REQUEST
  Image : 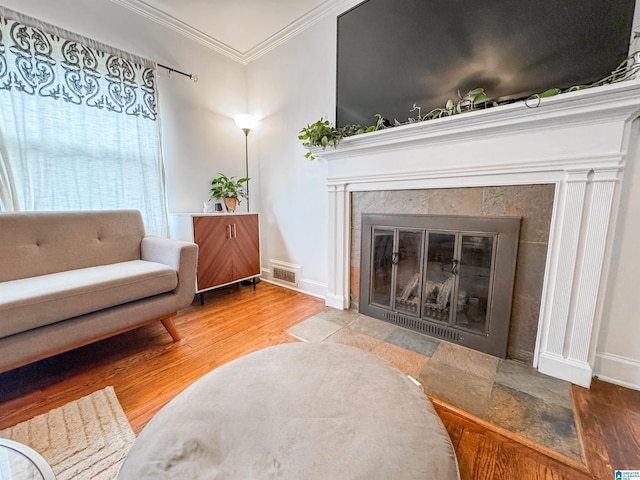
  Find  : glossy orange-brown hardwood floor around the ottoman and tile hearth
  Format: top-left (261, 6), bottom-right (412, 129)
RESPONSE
top-left (0, 282), bottom-right (640, 480)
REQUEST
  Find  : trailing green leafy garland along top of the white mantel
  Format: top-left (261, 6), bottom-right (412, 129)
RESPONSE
top-left (298, 32), bottom-right (640, 160)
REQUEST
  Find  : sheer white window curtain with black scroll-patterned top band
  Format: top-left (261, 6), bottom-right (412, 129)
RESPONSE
top-left (0, 7), bottom-right (167, 236)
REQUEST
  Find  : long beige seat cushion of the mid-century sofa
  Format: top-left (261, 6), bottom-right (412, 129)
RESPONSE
top-left (0, 260), bottom-right (178, 337)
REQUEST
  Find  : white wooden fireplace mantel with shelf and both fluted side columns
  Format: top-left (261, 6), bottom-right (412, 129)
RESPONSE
top-left (314, 80), bottom-right (640, 387)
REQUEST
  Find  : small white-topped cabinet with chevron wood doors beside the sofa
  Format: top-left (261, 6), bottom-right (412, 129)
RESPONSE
top-left (170, 213), bottom-right (260, 293)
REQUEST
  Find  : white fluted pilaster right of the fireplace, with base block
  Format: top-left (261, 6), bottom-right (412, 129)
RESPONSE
top-left (537, 168), bottom-right (619, 386)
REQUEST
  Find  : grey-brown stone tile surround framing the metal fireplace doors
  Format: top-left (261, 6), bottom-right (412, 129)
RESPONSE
top-left (349, 184), bottom-right (555, 365)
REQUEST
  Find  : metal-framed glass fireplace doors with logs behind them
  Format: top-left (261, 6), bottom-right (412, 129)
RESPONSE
top-left (359, 214), bottom-right (520, 358)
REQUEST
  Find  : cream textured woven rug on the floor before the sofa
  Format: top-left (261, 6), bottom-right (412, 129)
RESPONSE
top-left (0, 387), bottom-right (135, 480)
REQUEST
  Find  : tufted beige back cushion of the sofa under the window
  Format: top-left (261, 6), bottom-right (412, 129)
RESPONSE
top-left (0, 210), bottom-right (144, 281)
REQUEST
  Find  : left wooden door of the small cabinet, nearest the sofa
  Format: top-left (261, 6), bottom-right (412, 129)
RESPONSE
top-left (193, 217), bottom-right (236, 290)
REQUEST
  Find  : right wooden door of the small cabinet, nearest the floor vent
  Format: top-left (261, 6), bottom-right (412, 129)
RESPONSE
top-left (232, 215), bottom-right (260, 280)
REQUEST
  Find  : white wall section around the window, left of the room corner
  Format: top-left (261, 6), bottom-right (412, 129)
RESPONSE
top-left (0, 0), bottom-right (246, 212)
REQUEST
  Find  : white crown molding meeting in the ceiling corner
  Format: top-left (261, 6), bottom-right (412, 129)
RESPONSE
top-left (111, 0), bottom-right (353, 65)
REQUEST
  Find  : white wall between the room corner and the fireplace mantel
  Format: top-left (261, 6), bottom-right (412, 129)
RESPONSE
top-left (247, 17), bottom-right (344, 295)
